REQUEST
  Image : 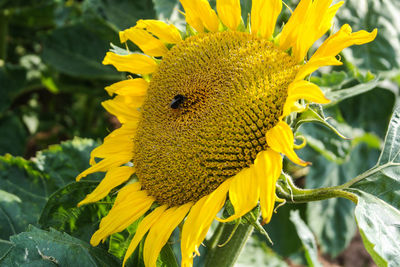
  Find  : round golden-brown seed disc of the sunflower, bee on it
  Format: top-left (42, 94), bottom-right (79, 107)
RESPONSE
top-left (132, 32), bottom-right (299, 207)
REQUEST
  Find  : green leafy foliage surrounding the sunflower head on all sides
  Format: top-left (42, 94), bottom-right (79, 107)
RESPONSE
top-left (0, 0), bottom-right (400, 266)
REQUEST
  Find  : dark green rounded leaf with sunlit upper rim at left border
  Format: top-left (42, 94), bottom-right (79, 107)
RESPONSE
top-left (0, 155), bottom-right (48, 244)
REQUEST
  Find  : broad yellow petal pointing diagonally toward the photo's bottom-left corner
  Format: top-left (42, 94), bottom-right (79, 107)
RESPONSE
top-left (90, 182), bottom-right (154, 246)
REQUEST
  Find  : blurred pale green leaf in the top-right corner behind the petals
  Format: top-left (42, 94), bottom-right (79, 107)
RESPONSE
top-left (337, 0), bottom-right (400, 72)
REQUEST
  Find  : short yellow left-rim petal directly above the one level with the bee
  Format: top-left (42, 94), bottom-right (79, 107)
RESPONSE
top-left (105, 78), bottom-right (149, 96)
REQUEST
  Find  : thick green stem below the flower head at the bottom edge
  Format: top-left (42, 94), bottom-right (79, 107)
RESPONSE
top-left (205, 223), bottom-right (253, 267)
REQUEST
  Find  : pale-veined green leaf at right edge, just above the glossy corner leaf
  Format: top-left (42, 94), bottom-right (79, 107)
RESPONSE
top-left (352, 103), bottom-right (400, 209)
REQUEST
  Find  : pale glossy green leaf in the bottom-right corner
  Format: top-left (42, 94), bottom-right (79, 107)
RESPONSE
top-left (354, 190), bottom-right (400, 266)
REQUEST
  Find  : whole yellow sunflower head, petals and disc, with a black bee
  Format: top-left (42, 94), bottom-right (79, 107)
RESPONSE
top-left (77, 0), bottom-right (377, 266)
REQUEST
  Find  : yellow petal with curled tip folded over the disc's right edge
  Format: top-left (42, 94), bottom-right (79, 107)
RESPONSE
top-left (266, 121), bottom-right (308, 166)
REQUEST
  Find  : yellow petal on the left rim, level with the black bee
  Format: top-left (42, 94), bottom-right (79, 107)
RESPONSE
top-left (101, 96), bottom-right (144, 123)
